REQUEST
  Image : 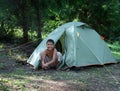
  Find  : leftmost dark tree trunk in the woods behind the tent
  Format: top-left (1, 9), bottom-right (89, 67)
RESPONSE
top-left (13, 0), bottom-right (29, 42)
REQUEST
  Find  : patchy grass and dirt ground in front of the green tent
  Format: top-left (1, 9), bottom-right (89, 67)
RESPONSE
top-left (0, 52), bottom-right (120, 91)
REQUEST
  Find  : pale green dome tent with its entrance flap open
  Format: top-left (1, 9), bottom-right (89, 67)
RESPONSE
top-left (27, 22), bottom-right (117, 69)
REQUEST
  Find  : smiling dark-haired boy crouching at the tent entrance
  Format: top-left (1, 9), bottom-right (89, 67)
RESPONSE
top-left (41, 39), bottom-right (62, 69)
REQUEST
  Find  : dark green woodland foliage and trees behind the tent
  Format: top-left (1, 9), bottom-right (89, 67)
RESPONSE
top-left (0, 0), bottom-right (120, 43)
